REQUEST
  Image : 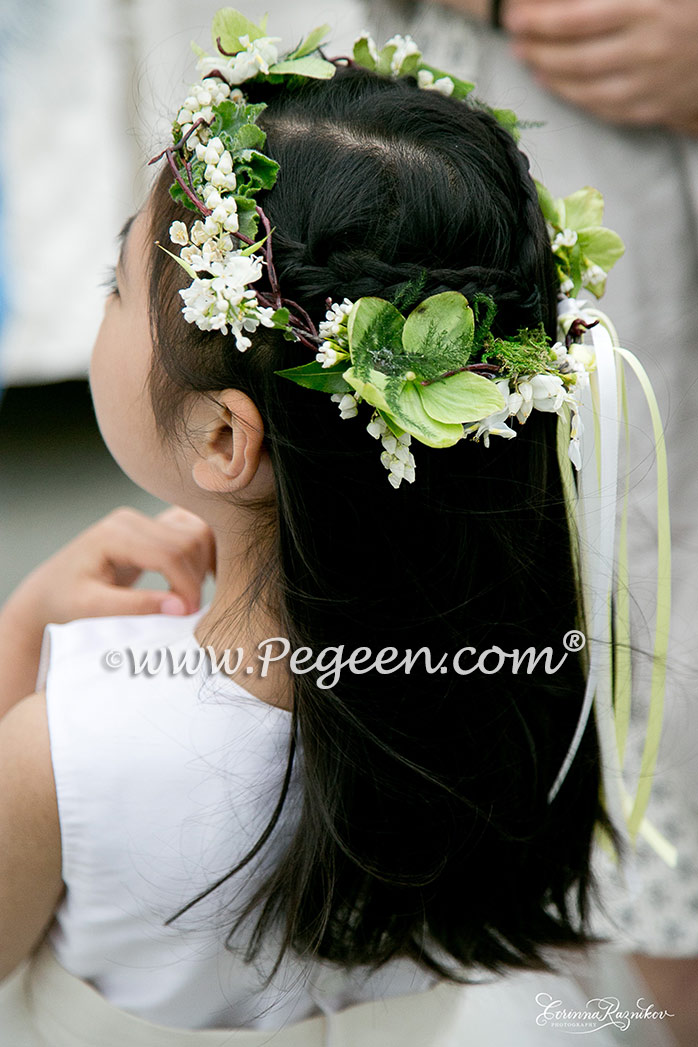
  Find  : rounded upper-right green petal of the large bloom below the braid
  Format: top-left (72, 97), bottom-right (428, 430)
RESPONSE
top-left (402, 291), bottom-right (475, 370)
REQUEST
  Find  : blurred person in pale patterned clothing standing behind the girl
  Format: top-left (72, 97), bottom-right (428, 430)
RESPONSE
top-left (371, 0), bottom-right (698, 1044)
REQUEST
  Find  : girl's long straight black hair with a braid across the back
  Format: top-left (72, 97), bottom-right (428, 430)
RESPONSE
top-left (146, 69), bottom-right (608, 980)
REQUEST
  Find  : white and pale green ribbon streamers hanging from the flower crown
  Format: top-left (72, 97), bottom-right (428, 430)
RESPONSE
top-left (548, 298), bottom-right (676, 865)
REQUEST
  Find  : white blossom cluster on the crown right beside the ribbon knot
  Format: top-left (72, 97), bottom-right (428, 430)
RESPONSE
top-left (465, 342), bottom-right (594, 469)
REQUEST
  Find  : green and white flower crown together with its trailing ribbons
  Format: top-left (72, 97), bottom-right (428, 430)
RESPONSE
top-left (151, 7), bottom-right (676, 864)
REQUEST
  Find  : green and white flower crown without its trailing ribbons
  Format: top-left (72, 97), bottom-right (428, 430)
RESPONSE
top-left (151, 7), bottom-right (624, 488)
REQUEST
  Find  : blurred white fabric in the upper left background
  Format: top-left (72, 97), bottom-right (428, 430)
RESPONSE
top-left (0, 0), bottom-right (364, 385)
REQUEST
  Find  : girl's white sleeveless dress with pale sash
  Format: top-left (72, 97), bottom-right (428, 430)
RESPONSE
top-left (0, 612), bottom-right (662, 1047)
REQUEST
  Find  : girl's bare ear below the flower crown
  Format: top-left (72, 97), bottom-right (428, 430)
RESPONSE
top-left (192, 389), bottom-right (264, 493)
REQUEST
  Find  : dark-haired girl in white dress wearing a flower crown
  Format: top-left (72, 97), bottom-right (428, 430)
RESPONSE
top-left (0, 10), bottom-right (644, 1047)
